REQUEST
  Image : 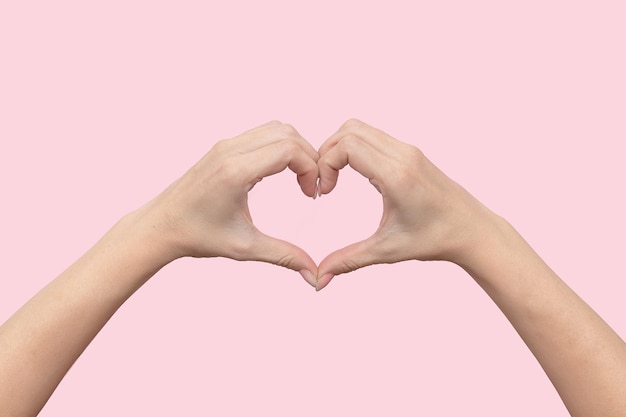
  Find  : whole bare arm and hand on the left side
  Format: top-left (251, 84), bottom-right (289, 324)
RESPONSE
top-left (0, 122), bottom-right (318, 417)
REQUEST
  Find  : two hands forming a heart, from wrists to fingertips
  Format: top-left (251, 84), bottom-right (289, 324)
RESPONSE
top-left (149, 120), bottom-right (492, 290)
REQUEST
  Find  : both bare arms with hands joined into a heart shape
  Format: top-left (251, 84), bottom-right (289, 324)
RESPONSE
top-left (0, 120), bottom-right (626, 417)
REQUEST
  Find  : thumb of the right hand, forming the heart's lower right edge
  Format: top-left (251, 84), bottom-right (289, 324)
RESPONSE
top-left (315, 235), bottom-right (385, 291)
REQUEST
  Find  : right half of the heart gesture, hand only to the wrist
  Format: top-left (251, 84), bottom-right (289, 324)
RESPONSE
top-left (317, 120), bottom-right (496, 290)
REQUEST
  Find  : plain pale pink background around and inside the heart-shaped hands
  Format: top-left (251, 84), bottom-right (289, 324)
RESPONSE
top-left (0, 0), bottom-right (626, 417)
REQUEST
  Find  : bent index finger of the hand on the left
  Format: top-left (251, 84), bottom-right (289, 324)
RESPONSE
top-left (241, 140), bottom-right (319, 197)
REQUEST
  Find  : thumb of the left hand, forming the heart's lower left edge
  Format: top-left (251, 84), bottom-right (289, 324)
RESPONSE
top-left (246, 231), bottom-right (317, 287)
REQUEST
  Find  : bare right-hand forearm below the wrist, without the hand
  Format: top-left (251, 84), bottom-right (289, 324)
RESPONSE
top-left (460, 219), bottom-right (626, 417)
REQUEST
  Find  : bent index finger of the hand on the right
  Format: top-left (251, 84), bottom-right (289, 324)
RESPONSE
top-left (317, 134), bottom-right (387, 194)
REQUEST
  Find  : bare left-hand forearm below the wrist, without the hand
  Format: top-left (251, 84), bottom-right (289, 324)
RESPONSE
top-left (0, 206), bottom-right (172, 417)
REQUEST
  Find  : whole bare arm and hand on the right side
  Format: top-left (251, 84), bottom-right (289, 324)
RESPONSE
top-left (317, 120), bottom-right (626, 417)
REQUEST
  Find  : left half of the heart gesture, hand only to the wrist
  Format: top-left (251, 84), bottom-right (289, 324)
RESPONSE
top-left (141, 118), bottom-right (318, 286)
